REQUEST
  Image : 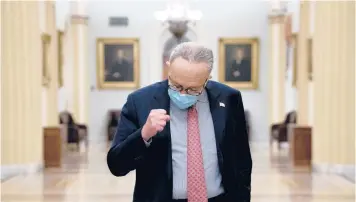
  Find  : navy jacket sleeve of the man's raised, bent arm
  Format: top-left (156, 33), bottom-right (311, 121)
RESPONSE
top-left (107, 95), bottom-right (147, 176)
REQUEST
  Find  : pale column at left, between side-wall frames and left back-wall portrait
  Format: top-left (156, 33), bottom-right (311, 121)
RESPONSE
top-left (66, 1), bottom-right (89, 124)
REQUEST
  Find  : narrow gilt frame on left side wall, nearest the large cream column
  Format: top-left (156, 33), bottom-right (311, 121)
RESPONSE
top-left (41, 34), bottom-right (51, 87)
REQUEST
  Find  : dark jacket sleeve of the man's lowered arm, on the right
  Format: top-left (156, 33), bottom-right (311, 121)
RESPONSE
top-left (234, 92), bottom-right (252, 202)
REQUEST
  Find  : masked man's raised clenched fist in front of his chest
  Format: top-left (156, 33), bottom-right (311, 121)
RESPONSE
top-left (142, 109), bottom-right (169, 141)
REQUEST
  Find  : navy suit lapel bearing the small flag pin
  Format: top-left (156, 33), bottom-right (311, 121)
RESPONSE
top-left (206, 81), bottom-right (226, 147)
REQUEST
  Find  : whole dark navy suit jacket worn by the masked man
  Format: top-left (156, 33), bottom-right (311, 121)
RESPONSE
top-left (107, 80), bottom-right (252, 202)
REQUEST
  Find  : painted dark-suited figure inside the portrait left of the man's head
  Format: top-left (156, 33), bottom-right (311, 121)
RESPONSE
top-left (105, 49), bottom-right (133, 81)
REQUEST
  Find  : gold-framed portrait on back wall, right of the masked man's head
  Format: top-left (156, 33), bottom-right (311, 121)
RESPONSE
top-left (219, 38), bottom-right (259, 89)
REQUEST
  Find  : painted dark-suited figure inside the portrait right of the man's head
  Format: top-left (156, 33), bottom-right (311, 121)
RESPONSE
top-left (225, 48), bottom-right (251, 82)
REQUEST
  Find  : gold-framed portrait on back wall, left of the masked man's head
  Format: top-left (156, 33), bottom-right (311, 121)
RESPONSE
top-left (96, 38), bottom-right (140, 89)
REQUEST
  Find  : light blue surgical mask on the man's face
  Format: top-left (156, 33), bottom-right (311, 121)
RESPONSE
top-left (168, 89), bottom-right (198, 109)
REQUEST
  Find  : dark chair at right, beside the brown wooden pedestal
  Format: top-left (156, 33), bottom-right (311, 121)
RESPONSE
top-left (270, 111), bottom-right (297, 149)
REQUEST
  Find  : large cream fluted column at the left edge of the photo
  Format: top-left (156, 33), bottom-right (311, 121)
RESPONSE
top-left (1, 1), bottom-right (43, 173)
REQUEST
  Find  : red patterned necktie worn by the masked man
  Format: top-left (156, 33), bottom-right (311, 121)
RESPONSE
top-left (187, 106), bottom-right (208, 202)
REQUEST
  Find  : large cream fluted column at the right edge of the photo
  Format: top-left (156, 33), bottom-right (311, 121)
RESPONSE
top-left (313, 1), bottom-right (355, 178)
